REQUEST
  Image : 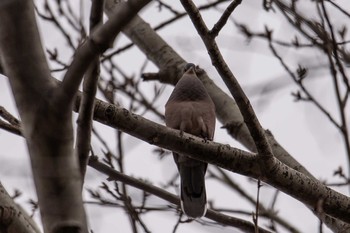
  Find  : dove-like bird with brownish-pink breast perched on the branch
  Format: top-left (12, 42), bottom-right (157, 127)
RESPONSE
top-left (165, 63), bottom-right (215, 219)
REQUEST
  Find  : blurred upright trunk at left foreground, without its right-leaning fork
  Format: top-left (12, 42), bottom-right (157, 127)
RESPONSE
top-left (0, 0), bottom-right (87, 233)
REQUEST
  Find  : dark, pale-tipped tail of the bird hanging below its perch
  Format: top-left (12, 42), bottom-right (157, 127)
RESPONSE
top-left (179, 161), bottom-right (207, 219)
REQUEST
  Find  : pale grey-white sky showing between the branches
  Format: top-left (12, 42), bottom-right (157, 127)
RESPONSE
top-left (0, 0), bottom-right (350, 233)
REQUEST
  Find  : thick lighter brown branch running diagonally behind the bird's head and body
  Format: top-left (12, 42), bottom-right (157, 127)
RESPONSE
top-left (105, 0), bottom-right (313, 182)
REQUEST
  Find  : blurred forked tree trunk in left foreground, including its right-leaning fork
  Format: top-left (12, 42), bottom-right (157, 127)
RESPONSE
top-left (0, 0), bottom-right (149, 233)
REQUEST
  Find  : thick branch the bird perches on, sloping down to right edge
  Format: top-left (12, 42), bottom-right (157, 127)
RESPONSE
top-left (72, 97), bottom-right (350, 223)
